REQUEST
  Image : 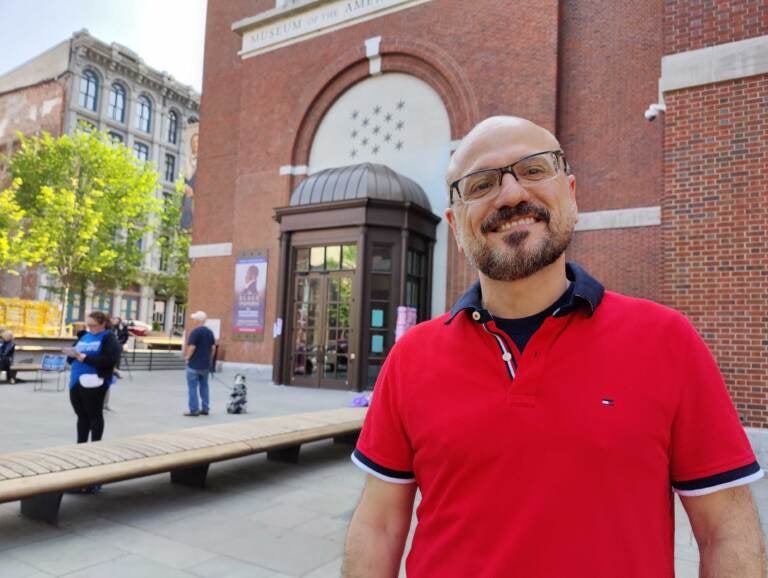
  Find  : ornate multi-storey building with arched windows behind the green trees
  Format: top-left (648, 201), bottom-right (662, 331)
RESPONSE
top-left (0, 30), bottom-right (200, 331)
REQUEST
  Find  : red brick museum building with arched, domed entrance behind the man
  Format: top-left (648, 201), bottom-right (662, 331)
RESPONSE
top-left (190, 0), bottom-right (768, 427)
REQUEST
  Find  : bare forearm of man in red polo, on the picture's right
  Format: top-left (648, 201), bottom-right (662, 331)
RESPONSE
top-left (681, 486), bottom-right (766, 578)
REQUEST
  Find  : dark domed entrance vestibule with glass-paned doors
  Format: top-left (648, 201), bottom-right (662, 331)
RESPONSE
top-left (274, 163), bottom-right (440, 391)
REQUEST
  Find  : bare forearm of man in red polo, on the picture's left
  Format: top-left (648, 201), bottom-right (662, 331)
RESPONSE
top-left (341, 475), bottom-right (416, 578)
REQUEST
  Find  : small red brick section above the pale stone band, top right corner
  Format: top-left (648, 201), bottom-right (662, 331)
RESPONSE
top-left (664, 0), bottom-right (768, 54)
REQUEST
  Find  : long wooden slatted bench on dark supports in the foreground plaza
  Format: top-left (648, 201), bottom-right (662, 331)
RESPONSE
top-left (0, 408), bottom-right (366, 524)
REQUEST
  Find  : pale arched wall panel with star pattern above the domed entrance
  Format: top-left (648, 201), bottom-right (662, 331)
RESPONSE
top-left (307, 72), bottom-right (452, 317)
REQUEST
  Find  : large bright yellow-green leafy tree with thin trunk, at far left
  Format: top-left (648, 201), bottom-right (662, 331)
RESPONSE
top-left (0, 130), bottom-right (162, 330)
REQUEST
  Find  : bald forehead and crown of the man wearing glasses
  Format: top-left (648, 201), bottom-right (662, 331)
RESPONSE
top-left (448, 116), bottom-right (560, 182)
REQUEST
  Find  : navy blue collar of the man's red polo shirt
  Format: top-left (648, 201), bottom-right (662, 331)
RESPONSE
top-left (445, 262), bottom-right (605, 325)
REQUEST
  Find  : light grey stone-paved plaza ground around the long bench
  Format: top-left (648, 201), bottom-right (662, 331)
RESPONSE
top-left (0, 371), bottom-right (768, 578)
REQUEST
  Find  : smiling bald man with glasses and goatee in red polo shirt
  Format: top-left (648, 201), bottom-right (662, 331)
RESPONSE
top-left (342, 117), bottom-right (765, 578)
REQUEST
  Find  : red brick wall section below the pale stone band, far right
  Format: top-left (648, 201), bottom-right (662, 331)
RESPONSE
top-left (662, 74), bottom-right (768, 427)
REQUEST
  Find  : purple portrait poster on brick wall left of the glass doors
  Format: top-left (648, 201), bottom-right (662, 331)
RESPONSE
top-left (232, 251), bottom-right (269, 341)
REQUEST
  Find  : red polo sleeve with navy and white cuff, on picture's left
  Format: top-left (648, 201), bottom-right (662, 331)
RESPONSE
top-left (352, 348), bottom-right (416, 484)
